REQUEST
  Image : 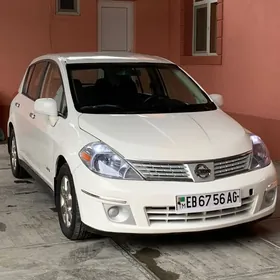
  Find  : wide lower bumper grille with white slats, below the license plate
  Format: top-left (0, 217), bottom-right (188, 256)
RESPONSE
top-left (145, 196), bottom-right (254, 226)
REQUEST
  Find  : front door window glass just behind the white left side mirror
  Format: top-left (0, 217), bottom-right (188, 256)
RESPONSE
top-left (41, 63), bottom-right (67, 116)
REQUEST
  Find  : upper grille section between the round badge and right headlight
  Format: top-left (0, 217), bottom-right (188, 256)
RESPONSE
top-left (214, 153), bottom-right (251, 178)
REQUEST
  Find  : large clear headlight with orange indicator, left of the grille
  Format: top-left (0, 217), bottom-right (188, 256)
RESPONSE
top-left (79, 142), bottom-right (142, 180)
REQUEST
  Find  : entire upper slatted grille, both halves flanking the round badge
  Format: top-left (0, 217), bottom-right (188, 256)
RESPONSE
top-left (130, 153), bottom-right (251, 182)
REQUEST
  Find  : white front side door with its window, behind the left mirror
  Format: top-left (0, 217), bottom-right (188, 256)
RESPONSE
top-left (31, 62), bottom-right (67, 186)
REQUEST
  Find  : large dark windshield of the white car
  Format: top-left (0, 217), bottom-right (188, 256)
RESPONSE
top-left (67, 63), bottom-right (217, 114)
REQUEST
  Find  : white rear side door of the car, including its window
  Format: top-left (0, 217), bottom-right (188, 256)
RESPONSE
top-left (20, 61), bottom-right (48, 171)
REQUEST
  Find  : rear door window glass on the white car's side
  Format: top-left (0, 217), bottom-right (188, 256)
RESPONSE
top-left (25, 62), bottom-right (48, 101)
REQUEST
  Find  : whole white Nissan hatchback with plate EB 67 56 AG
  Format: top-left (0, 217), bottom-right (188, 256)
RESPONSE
top-left (7, 53), bottom-right (277, 240)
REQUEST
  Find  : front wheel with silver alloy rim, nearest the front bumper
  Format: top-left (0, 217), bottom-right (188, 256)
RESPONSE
top-left (55, 163), bottom-right (93, 240)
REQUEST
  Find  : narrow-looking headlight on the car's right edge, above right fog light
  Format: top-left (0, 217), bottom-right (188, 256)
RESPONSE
top-left (250, 134), bottom-right (271, 170)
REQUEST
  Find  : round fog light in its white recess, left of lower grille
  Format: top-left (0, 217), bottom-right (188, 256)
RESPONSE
top-left (103, 203), bottom-right (135, 225)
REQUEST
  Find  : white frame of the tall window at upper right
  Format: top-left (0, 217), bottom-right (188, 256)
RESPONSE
top-left (192, 0), bottom-right (218, 56)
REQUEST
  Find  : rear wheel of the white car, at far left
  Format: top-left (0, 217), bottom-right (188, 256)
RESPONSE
top-left (10, 129), bottom-right (29, 179)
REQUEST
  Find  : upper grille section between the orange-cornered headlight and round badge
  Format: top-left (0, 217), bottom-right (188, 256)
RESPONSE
top-left (132, 162), bottom-right (192, 181)
